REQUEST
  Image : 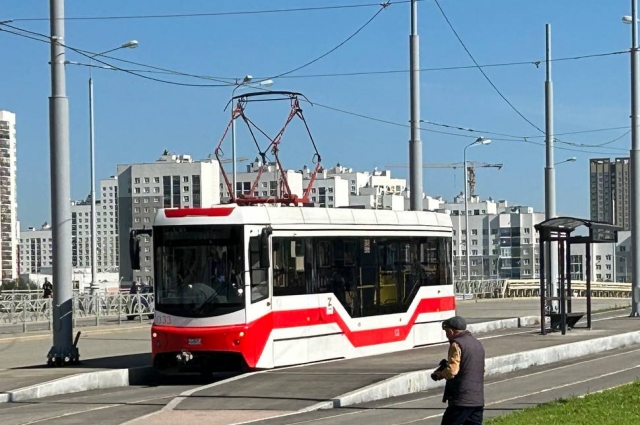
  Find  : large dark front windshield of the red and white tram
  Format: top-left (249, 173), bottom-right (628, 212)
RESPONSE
top-left (154, 226), bottom-right (245, 317)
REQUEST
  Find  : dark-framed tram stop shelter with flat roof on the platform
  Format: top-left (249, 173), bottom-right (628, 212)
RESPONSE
top-left (535, 217), bottom-right (622, 335)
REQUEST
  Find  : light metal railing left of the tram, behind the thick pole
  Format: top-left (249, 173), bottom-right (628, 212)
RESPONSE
top-left (0, 291), bottom-right (155, 332)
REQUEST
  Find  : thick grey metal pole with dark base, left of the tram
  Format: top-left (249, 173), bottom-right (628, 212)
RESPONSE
top-left (47, 0), bottom-right (79, 365)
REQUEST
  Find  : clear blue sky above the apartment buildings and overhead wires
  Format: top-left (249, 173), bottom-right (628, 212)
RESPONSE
top-left (0, 0), bottom-right (630, 228)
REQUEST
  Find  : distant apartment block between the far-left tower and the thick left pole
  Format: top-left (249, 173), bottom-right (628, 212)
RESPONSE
top-left (18, 223), bottom-right (53, 274)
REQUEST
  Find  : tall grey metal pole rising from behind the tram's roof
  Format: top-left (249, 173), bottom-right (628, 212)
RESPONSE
top-left (409, 0), bottom-right (423, 211)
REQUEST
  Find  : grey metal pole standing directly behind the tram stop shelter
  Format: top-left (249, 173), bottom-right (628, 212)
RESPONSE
top-left (543, 24), bottom-right (560, 312)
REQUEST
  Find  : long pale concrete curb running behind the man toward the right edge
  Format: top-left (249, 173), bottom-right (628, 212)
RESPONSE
top-left (328, 331), bottom-right (640, 409)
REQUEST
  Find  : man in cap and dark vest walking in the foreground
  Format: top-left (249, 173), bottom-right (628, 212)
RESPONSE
top-left (431, 316), bottom-right (484, 425)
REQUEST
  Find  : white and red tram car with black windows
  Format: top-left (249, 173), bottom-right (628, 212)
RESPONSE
top-left (131, 205), bottom-right (455, 372)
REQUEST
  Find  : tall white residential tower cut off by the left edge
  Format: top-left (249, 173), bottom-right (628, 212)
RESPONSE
top-left (0, 111), bottom-right (19, 280)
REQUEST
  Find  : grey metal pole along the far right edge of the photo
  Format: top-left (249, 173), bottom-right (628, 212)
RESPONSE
top-left (630, 0), bottom-right (640, 316)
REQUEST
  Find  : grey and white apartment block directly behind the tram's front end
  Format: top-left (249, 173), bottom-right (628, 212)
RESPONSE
top-left (117, 151), bottom-right (220, 284)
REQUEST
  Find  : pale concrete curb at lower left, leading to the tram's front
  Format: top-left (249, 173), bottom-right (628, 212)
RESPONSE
top-left (0, 366), bottom-right (154, 403)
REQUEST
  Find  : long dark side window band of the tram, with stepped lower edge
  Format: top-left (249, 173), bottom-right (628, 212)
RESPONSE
top-left (273, 237), bottom-right (452, 317)
